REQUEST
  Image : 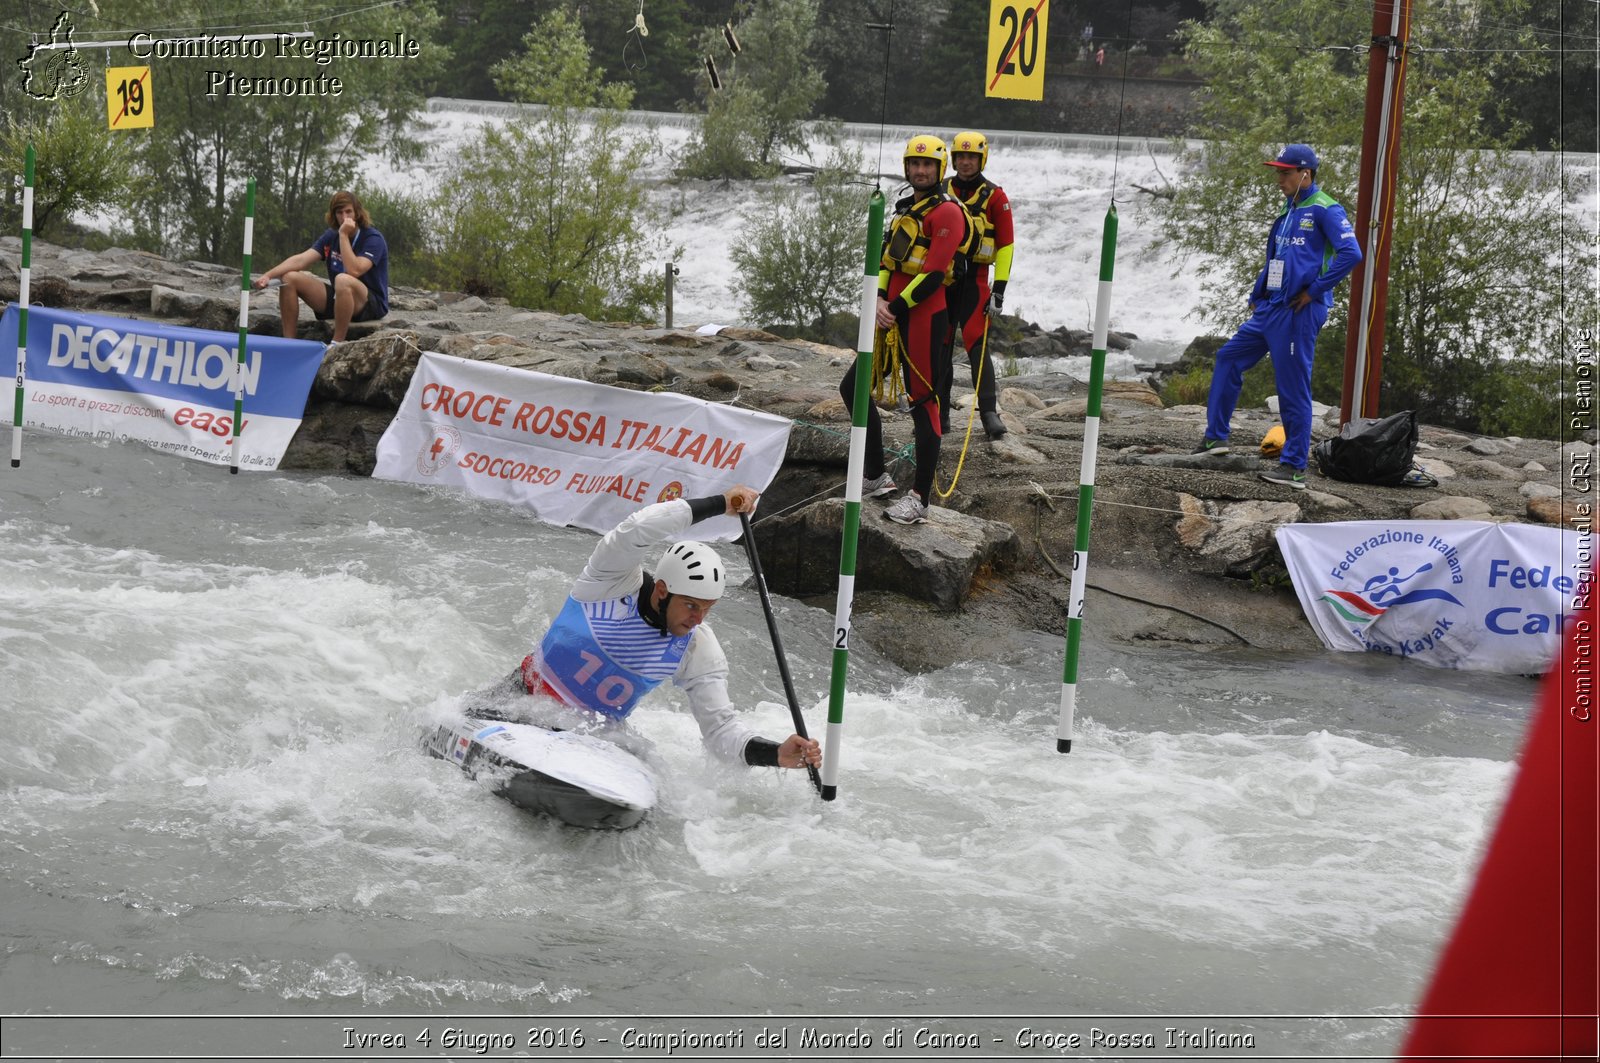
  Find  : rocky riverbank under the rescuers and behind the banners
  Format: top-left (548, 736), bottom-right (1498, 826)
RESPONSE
top-left (0, 237), bottom-right (1594, 669)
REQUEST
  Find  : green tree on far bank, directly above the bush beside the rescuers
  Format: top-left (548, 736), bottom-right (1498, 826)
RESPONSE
top-left (680, 0), bottom-right (826, 178)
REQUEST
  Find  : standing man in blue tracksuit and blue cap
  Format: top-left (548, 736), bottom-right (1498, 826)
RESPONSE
top-left (1195, 144), bottom-right (1362, 490)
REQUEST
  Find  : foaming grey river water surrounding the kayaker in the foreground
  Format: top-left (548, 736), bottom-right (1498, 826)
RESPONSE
top-left (0, 434), bottom-right (1534, 1060)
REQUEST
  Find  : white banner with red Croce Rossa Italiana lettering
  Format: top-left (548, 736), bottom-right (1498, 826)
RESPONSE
top-left (373, 351), bottom-right (790, 540)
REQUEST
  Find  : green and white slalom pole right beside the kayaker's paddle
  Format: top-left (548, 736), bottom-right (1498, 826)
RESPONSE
top-left (821, 191), bottom-right (883, 800)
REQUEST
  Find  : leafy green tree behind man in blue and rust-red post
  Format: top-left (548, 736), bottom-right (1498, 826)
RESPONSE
top-left (1157, 0), bottom-right (1595, 435)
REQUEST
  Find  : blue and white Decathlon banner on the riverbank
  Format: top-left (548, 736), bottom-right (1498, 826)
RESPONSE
top-left (0, 303), bottom-right (325, 471)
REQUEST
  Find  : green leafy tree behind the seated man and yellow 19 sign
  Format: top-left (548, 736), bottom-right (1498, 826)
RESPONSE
top-left (90, 0), bottom-right (448, 261)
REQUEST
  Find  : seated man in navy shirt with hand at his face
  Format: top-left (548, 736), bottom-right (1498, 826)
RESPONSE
top-left (254, 192), bottom-right (389, 343)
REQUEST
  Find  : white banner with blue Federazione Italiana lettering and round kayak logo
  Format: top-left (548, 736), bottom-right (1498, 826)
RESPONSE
top-left (1277, 520), bottom-right (1594, 672)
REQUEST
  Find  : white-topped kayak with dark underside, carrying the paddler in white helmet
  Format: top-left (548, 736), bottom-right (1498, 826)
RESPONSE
top-left (422, 717), bottom-right (656, 831)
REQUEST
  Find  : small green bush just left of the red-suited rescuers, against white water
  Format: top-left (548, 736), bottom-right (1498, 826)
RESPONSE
top-left (730, 141), bottom-right (870, 339)
